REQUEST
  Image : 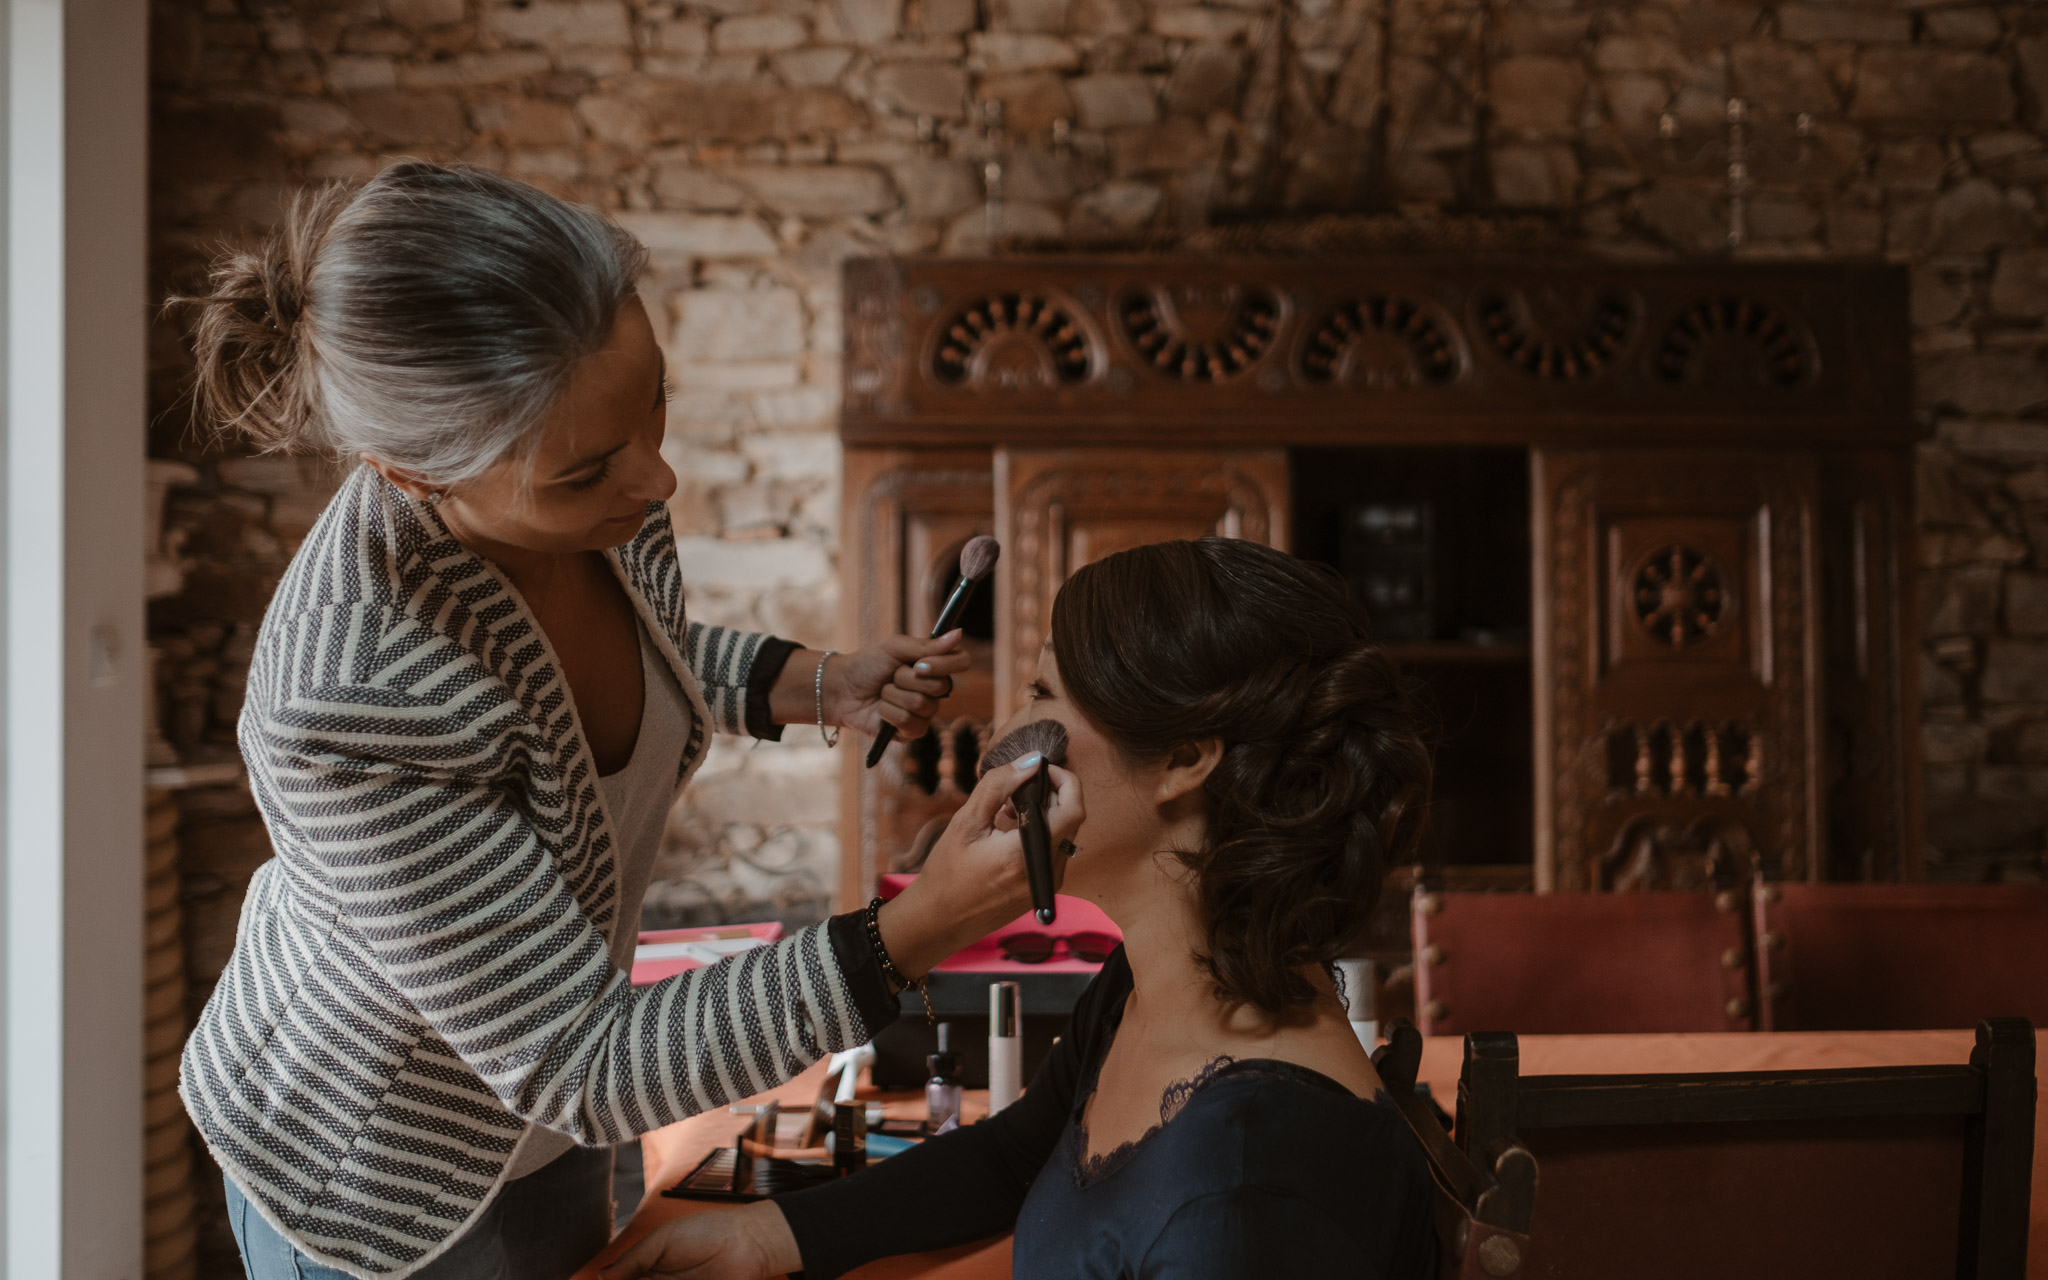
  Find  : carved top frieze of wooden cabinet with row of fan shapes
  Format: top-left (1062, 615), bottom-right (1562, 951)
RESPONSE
top-left (842, 256), bottom-right (1915, 446)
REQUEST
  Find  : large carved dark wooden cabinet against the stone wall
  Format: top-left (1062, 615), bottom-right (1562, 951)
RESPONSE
top-left (842, 256), bottom-right (1919, 901)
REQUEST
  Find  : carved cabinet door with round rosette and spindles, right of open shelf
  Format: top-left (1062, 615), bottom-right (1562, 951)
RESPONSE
top-left (1532, 449), bottom-right (1825, 889)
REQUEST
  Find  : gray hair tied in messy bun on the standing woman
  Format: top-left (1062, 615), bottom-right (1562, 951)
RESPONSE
top-left (178, 162), bottom-right (647, 483)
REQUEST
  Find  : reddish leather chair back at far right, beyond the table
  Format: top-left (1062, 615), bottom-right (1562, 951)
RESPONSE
top-left (1753, 881), bottom-right (2048, 1030)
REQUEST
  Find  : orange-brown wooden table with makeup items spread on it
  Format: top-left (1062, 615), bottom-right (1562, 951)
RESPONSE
top-left (578, 1030), bottom-right (2048, 1280)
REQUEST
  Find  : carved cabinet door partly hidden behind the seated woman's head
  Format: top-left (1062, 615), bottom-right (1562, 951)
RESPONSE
top-left (995, 449), bottom-right (1288, 719)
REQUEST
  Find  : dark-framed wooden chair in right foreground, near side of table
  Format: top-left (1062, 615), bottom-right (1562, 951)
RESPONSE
top-left (1456, 1018), bottom-right (2034, 1280)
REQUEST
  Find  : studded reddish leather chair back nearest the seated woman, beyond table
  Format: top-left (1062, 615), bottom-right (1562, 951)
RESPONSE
top-left (1413, 891), bottom-right (1751, 1036)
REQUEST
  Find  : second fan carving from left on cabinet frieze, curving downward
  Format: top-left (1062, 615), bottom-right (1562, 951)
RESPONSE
top-left (1114, 285), bottom-right (1280, 383)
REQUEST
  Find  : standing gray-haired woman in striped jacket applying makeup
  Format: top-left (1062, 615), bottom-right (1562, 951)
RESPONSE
top-left (182, 164), bottom-right (1081, 1280)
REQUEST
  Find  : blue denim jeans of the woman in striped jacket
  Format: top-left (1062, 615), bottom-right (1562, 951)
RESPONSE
top-left (227, 1147), bottom-right (612, 1280)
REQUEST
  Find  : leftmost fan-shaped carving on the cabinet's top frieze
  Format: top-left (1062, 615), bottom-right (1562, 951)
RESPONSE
top-left (926, 289), bottom-right (1102, 391)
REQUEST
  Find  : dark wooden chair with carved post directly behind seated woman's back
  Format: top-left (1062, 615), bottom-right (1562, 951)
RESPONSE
top-left (1372, 1022), bottom-right (1536, 1280)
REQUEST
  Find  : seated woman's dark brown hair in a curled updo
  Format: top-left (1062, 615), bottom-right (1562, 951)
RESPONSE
top-left (1053, 539), bottom-right (1430, 1016)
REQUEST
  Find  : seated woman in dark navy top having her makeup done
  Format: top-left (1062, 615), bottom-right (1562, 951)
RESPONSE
top-left (604, 539), bottom-right (1436, 1280)
